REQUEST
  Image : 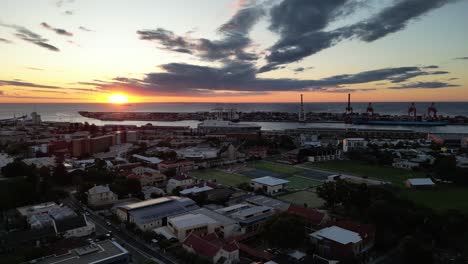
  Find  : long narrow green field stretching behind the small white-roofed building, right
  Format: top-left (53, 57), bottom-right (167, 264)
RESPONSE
top-left (305, 160), bottom-right (426, 186)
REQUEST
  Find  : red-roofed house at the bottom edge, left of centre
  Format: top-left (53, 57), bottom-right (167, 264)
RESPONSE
top-left (182, 233), bottom-right (239, 264)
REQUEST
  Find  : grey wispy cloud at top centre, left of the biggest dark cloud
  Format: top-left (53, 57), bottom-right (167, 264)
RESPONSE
top-left (137, 1), bottom-right (265, 61)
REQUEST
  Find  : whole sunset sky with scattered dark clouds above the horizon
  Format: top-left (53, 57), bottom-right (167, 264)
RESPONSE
top-left (0, 0), bottom-right (468, 103)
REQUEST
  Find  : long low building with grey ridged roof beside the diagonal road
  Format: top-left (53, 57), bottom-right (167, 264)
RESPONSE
top-left (116, 196), bottom-right (198, 231)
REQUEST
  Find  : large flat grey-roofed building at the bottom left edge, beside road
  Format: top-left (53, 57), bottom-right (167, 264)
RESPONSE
top-left (30, 240), bottom-right (131, 264)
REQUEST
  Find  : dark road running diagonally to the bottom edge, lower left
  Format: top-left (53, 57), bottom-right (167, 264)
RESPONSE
top-left (64, 198), bottom-right (176, 264)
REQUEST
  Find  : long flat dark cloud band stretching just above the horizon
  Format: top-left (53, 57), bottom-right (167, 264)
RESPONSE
top-left (80, 62), bottom-right (446, 96)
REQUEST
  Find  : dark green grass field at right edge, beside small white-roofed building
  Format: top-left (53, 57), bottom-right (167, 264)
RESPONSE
top-left (400, 186), bottom-right (468, 216)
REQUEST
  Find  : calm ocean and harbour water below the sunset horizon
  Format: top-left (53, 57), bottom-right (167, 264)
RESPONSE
top-left (0, 102), bottom-right (468, 133)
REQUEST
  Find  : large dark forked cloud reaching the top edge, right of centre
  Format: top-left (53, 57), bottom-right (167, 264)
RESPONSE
top-left (260, 0), bottom-right (457, 72)
